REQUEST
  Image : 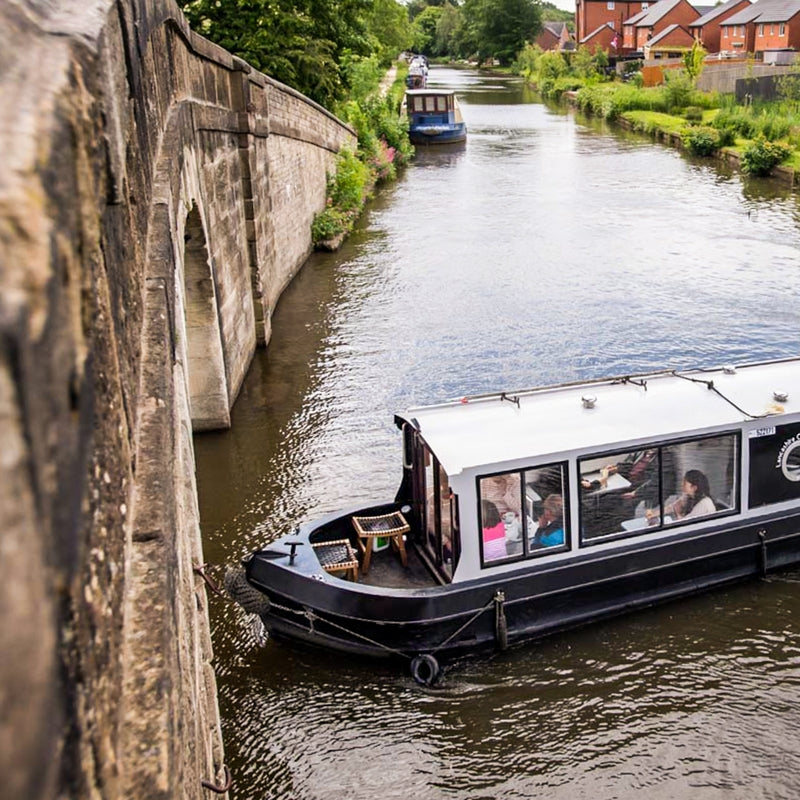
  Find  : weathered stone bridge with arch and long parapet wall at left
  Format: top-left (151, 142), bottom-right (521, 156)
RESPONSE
top-left (0, 0), bottom-right (354, 800)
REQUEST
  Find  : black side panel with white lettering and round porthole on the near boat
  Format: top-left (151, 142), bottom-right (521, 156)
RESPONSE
top-left (749, 422), bottom-right (800, 508)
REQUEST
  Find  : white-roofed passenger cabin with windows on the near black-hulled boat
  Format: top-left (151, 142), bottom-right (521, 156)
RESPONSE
top-left (396, 361), bottom-right (800, 582)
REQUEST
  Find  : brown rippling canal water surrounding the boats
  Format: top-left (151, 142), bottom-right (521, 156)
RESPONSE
top-left (195, 69), bottom-right (800, 800)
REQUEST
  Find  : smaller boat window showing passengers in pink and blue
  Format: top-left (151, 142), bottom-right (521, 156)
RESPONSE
top-left (478, 464), bottom-right (567, 564)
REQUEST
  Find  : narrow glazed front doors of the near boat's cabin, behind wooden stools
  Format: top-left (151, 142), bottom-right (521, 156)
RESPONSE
top-left (414, 437), bottom-right (459, 578)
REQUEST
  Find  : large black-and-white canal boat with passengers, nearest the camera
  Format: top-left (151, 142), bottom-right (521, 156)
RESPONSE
top-left (234, 359), bottom-right (800, 683)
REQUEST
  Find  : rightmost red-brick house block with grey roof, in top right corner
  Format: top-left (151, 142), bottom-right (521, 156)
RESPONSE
top-left (720, 0), bottom-right (800, 56)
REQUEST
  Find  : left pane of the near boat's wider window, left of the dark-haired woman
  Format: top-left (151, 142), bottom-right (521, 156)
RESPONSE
top-left (578, 448), bottom-right (661, 540)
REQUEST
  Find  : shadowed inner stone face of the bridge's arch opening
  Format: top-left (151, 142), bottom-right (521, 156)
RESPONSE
top-left (183, 204), bottom-right (231, 431)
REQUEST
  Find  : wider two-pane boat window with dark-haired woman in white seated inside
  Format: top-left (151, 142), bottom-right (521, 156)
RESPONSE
top-left (578, 434), bottom-right (739, 541)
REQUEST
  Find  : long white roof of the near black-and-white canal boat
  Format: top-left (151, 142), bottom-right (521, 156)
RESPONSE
top-left (398, 358), bottom-right (800, 476)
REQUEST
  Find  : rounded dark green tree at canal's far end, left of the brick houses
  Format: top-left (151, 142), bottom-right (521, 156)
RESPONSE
top-left (463, 0), bottom-right (542, 64)
